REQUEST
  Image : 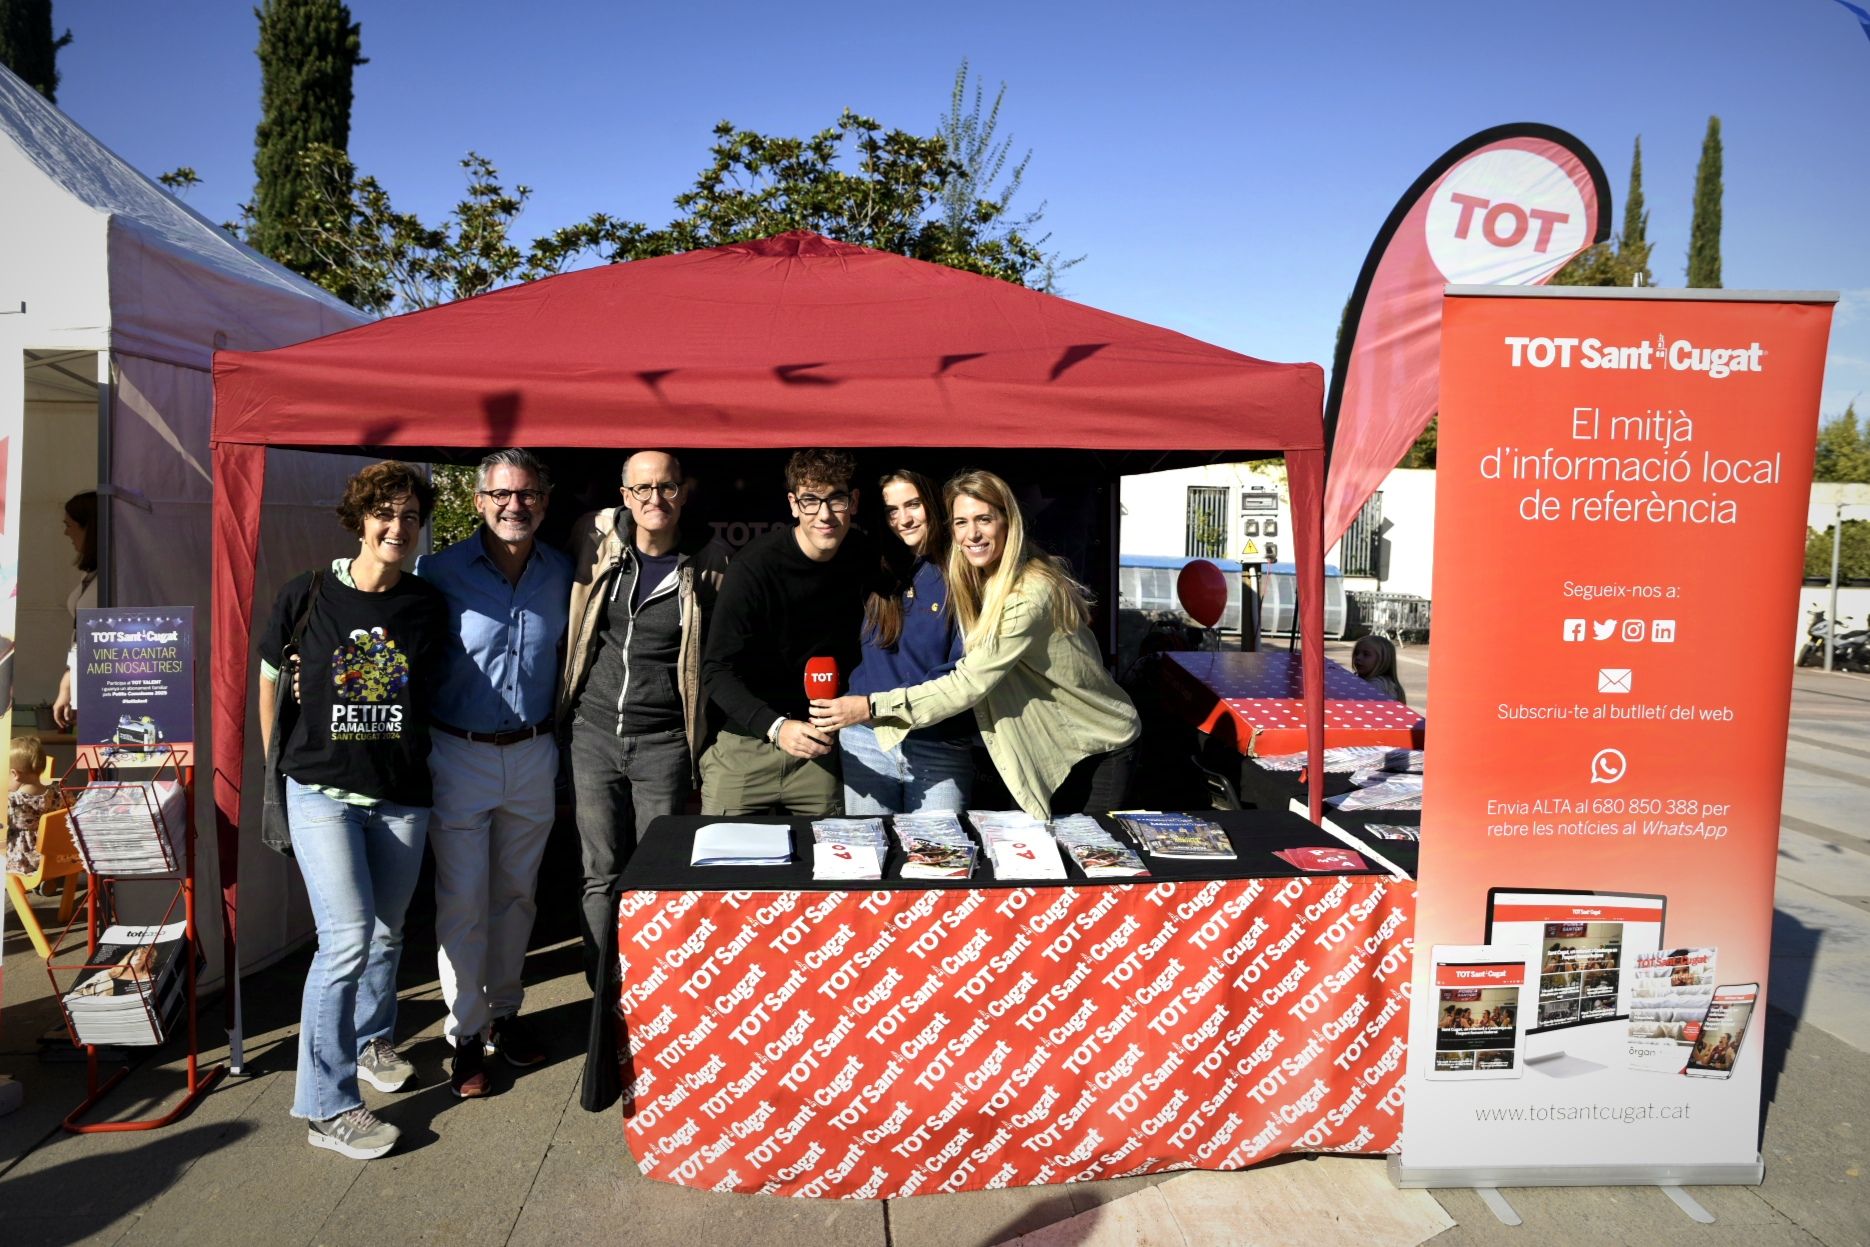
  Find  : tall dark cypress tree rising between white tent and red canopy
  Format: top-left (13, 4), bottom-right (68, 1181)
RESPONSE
top-left (247, 0), bottom-right (365, 280)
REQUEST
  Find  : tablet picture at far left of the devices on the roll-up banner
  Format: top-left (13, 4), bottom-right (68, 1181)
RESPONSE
top-left (1423, 944), bottom-right (1533, 1082)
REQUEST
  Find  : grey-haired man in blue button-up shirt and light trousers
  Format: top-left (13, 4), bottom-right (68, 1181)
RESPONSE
top-left (415, 451), bottom-right (572, 1097)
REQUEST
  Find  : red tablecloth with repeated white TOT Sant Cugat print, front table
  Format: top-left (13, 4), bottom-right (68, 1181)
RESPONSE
top-left (617, 877), bottom-right (1414, 1198)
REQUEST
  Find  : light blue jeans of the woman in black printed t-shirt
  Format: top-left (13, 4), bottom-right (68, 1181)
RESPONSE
top-left (286, 778), bottom-right (428, 1120)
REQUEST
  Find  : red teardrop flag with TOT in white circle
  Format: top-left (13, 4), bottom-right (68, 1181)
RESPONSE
top-left (1324, 122), bottom-right (1610, 546)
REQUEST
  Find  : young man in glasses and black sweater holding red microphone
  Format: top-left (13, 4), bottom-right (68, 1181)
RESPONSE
top-left (701, 451), bottom-right (875, 815)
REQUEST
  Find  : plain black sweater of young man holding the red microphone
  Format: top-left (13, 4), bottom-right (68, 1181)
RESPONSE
top-left (701, 527), bottom-right (877, 738)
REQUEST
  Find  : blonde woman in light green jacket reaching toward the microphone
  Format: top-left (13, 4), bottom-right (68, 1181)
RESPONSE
top-left (812, 471), bottom-right (1141, 819)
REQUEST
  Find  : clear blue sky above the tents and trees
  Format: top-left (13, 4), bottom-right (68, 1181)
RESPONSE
top-left (54, 0), bottom-right (1870, 413)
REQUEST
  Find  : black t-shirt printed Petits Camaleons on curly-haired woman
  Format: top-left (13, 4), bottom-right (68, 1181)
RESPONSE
top-left (260, 572), bottom-right (449, 806)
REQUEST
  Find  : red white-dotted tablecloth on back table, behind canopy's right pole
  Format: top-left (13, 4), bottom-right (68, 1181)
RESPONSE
top-left (1163, 651), bottom-right (1427, 757)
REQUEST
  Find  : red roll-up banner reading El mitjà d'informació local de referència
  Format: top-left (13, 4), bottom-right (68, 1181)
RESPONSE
top-left (1391, 286), bottom-right (1836, 1187)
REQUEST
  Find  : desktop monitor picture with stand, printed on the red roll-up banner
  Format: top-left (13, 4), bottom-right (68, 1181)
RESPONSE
top-left (1487, 888), bottom-right (1668, 1079)
